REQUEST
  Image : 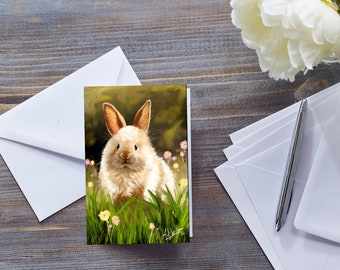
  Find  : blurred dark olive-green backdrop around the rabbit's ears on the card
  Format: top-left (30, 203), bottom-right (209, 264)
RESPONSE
top-left (84, 85), bottom-right (187, 163)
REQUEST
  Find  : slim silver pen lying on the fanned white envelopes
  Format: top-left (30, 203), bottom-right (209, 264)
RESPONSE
top-left (275, 99), bottom-right (307, 231)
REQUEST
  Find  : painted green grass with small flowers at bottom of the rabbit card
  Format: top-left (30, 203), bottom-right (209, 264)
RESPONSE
top-left (86, 151), bottom-right (189, 244)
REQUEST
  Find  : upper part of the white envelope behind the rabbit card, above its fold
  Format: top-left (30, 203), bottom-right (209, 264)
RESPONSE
top-left (0, 47), bottom-right (139, 159)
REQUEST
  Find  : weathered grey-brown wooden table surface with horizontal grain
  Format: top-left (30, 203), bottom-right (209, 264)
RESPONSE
top-left (0, 0), bottom-right (340, 270)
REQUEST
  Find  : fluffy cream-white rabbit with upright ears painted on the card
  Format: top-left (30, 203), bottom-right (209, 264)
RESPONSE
top-left (99, 100), bottom-right (175, 201)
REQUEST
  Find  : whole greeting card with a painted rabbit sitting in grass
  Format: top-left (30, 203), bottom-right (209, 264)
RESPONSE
top-left (84, 85), bottom-right (191, 244)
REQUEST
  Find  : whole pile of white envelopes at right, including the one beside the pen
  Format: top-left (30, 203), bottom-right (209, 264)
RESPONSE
top-left (215, 84), bottom-right (340, 270)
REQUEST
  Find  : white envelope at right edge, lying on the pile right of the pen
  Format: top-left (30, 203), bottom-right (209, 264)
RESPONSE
top-left (294, 110), bottom-right (340, 243)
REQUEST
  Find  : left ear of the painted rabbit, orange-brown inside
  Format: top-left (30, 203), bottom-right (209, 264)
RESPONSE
top-left (103, 102), bottom-right (126, 135)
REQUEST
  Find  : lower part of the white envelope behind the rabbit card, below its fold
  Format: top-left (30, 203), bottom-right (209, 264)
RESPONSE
top-left (0, 139), bottom-right (85, 221)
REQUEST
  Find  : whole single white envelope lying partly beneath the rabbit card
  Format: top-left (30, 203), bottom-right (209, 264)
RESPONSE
top-left (0, 47), bottom-right (140, 221)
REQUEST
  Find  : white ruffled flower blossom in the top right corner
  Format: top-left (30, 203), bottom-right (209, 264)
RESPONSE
top-left (230, 0), bottom-right (340, 81)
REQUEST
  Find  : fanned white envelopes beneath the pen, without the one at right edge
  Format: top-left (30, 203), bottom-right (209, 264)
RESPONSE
top-left (215, 84), bottom-right (340, 269)
